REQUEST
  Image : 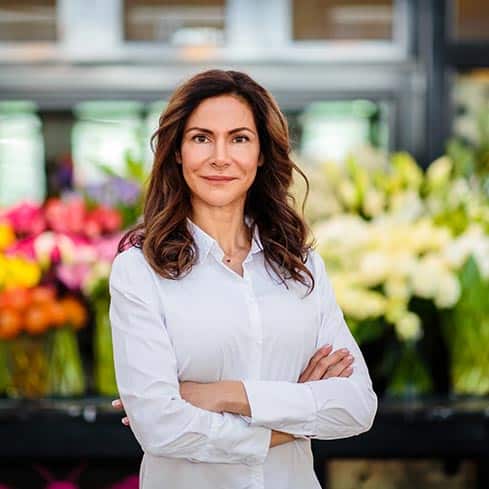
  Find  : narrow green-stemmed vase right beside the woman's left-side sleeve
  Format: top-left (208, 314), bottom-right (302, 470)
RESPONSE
top-left (94, 299), bottom-right (117, 396)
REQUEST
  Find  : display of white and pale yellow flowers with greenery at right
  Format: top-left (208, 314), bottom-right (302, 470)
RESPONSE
top-left (296, 138), bottom-right (489, 395)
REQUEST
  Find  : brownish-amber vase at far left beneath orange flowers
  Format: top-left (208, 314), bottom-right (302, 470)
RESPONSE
top-left (5, 333), bottom-right (50, 399)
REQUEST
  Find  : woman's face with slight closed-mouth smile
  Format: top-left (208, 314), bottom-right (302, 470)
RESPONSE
top-left (181, 95), bottom-right (262, 211)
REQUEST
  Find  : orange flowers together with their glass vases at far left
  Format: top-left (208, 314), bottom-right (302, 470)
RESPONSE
top-left (0, 282), bottom-right (87, 398)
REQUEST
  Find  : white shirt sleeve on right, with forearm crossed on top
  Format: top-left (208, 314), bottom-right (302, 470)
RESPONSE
top-left (243, 251), bottom-right (377, 440)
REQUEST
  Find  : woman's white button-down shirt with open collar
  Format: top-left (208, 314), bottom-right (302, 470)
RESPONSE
top-left (110, 218), bottom-right (377, 489)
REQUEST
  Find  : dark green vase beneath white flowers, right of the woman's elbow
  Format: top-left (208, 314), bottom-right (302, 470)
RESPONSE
top-left (386, 340), bottom-right (433, 399)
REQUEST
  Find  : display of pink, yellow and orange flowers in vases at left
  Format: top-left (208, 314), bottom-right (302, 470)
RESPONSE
top-left (0, 194), bottom-right (130, 397)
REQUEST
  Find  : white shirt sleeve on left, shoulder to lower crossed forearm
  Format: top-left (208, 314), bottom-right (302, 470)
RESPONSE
top-left (109, 249), bottom-right (271, 465)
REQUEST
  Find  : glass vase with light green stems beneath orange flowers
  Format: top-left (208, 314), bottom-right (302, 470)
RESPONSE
top-left (49, 326), bottom-right (85, 396)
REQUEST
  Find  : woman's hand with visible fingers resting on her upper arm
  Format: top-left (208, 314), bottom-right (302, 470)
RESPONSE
top-left (299, 345), bottom-right (354, 383)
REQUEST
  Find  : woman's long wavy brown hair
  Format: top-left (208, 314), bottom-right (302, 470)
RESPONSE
top-left (118, 70), bottom-right (314, 293)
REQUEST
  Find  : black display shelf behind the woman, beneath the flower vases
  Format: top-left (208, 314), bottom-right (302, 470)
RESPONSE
top-left (0, 397), bottom-right (489, 489)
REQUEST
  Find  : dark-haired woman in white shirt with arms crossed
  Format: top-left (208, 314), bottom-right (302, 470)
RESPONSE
top-left (110, 70), bottom-right (377, 489)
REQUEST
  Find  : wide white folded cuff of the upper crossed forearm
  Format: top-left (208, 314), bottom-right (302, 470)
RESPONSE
top-left (242, 380), bottom-right (316, 433)
